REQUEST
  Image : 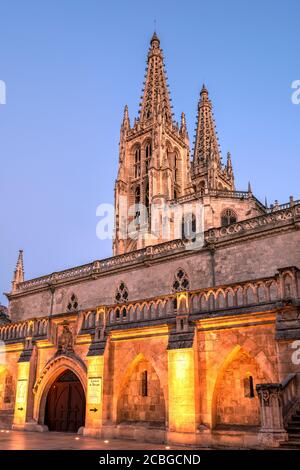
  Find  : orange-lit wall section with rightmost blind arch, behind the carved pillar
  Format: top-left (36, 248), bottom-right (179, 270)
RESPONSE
top-left (197, 313), bottom-right (279, 428)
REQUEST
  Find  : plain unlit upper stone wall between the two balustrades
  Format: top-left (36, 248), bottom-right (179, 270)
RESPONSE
top-left (10, 225), bottom-right (300, 321)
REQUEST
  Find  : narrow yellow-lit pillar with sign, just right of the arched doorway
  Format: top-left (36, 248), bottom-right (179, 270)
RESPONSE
top-left (83, 355), bottom-right (104, 437)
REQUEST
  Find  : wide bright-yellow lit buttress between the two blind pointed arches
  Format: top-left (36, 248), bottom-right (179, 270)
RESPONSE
top-left (168, 348), bottom-right (196, 444)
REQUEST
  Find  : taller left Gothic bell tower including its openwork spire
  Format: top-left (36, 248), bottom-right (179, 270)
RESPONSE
top-left (113, 33), bottom-right (192, 255)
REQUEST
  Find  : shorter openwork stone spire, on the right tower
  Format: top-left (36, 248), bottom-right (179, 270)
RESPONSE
top-left (193, 85), bottom-right (221, 165)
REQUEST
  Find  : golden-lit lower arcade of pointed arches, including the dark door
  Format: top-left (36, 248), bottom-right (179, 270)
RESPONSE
top-left (0, 314), bottom-right (284, 445)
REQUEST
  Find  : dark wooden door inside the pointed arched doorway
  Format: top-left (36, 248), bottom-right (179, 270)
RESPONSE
top-left (45, 370), bottom-right (85, 432)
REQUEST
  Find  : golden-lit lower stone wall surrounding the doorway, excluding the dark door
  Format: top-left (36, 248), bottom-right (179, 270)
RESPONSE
top-left (0, 304), bottom-right (298, 445)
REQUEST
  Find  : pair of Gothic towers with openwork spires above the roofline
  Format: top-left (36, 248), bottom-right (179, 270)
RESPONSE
top-left (113, 33), bottom-right (257, 255)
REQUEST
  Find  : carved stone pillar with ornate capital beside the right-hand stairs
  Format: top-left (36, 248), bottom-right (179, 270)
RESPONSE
top-left (256, 383), bottom-right (288, 447)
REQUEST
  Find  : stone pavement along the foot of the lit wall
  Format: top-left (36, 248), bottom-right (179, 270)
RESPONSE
top-left (0, 430), bottom-right (192, 450)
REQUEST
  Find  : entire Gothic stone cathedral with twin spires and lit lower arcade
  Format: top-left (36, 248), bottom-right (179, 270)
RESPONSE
top-left (0, 33), bottom-right (300, 448)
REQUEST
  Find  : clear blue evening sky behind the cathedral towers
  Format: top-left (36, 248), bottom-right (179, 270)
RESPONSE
top-left (0, 0), bottom-right (300, 303)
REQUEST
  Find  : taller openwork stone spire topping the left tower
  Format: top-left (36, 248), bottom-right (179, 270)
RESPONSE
top-left (140, 33), bottom-right (172, 124)
